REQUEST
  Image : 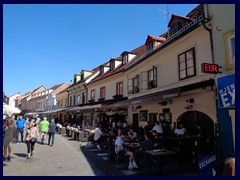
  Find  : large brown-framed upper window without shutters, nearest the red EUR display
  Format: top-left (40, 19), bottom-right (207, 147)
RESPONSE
top-left (178, 48), bottom-right (196, 80)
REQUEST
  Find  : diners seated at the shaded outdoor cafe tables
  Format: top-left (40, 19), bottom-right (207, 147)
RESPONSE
top-left (93, 121), bottom-right (188, 169)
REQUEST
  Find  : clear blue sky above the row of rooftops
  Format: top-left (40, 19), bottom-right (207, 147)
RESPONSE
top-left (3, 4), bottom-right (197, 96)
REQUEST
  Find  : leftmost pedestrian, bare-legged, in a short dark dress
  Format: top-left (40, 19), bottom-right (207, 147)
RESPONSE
top-left (3, 118), bottom-right (16, 161)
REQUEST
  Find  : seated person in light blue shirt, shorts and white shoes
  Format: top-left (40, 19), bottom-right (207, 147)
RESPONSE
top-left (115, 130), bottom-right (138, 169)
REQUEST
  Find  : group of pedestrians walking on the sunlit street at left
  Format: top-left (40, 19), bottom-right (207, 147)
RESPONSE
top-left (3, 115), bottom-right (56, 161)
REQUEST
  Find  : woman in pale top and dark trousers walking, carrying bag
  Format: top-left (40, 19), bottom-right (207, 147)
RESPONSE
top-left (25, 121), bottom-right (39, 159)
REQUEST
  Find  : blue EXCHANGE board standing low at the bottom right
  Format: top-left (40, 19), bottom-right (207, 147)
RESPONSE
top-left (198, 154), bottom-right (217, 176)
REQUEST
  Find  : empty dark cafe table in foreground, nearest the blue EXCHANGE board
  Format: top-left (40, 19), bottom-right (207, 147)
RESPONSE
top-left (145, 149), bottom-right (177, 174)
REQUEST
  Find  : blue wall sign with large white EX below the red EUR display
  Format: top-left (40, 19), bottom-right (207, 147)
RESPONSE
top-left (217, 74), bottom-right (235, 108)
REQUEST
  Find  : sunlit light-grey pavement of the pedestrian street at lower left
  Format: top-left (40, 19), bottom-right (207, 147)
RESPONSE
top-left (3, 134), bottom-right (104, 176)
